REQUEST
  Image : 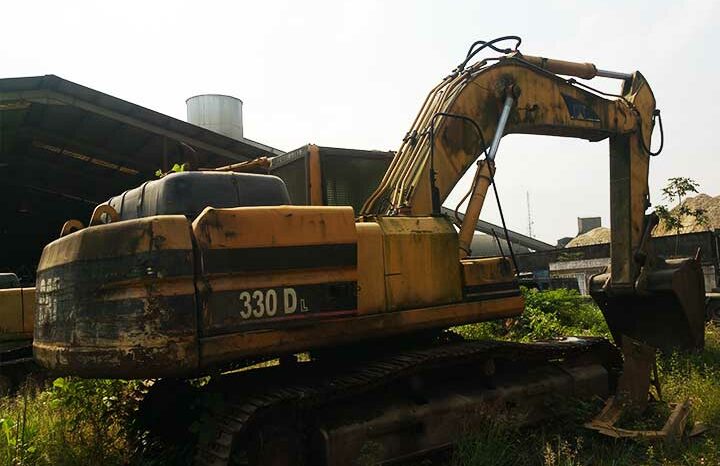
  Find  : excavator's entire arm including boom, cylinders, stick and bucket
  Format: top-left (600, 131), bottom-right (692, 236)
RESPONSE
top-left (362, 51), bottom-right (704, 348)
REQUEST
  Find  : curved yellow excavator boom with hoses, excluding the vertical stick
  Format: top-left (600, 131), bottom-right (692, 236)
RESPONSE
top-left (363, 57), bottom-right (655, 215)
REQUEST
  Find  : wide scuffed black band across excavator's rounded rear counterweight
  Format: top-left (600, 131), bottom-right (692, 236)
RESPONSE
top-left (35, 249), bottom-right (197, 345)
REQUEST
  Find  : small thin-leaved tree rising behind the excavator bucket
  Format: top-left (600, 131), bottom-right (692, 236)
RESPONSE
top-left (655, 177), bottom-right (708, 255)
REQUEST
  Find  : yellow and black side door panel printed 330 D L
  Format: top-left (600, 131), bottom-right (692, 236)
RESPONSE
top-left (193, 206), bottom-right (358, 337)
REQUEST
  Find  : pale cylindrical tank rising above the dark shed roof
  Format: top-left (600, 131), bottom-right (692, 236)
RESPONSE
top-left (185, 94), bottom-right (243, 140)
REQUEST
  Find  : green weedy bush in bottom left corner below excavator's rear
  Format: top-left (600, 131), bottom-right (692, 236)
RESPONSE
top-left (0, 378), bottom-right (138, 466)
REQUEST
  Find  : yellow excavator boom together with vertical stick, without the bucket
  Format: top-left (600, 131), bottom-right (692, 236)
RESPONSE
top-left (363, 55), bottom-right (655, 280)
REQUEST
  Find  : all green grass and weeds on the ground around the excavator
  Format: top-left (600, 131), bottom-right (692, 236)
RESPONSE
top-left (0, 290), bottom-right (720, 466)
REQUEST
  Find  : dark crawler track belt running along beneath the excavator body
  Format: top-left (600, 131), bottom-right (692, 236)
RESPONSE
top-left (190, 338), bottom-right (621, 466)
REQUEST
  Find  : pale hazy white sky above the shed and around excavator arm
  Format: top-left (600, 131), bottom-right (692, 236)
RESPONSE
top-left (0, 0), bottom-right (720, 244)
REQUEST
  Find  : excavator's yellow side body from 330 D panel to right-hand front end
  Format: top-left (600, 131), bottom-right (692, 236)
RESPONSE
top-left (193, 213), bottom-right (523, 369)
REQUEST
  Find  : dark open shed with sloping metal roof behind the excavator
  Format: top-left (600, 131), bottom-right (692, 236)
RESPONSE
top-left (0, 75), bottom-right (283, 282)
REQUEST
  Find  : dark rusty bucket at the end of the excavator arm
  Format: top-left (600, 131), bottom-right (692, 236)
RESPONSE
top-left (590, 258), bottom-right (705, 352)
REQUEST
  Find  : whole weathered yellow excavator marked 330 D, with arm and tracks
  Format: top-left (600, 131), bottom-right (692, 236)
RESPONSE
top-left (33, 36), bottom-right (704, 466)
